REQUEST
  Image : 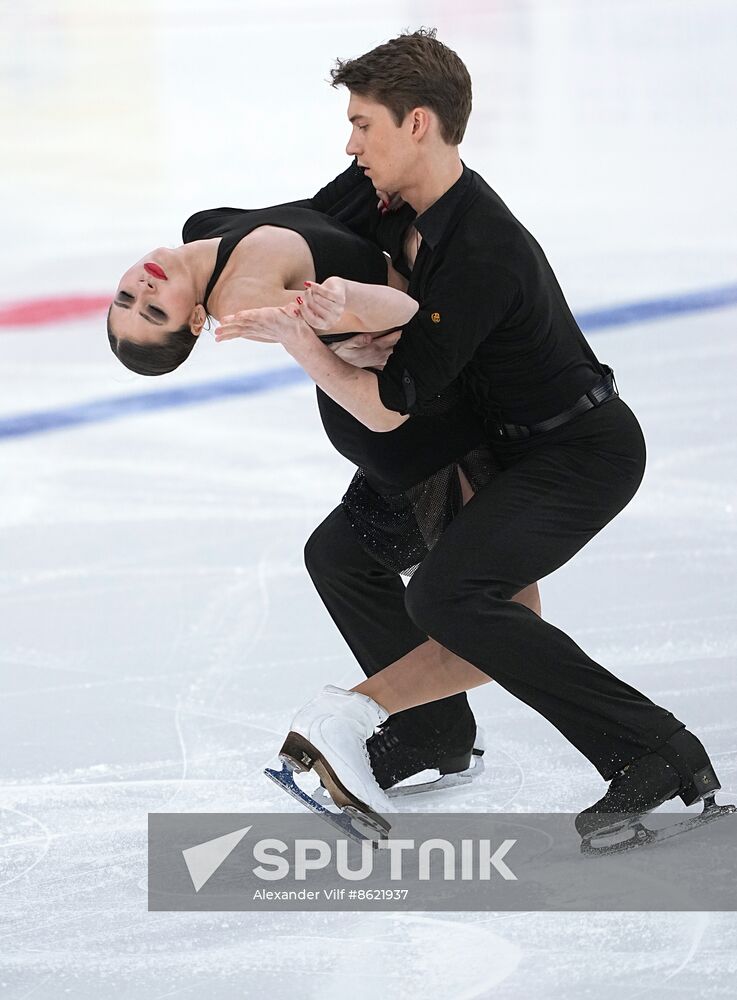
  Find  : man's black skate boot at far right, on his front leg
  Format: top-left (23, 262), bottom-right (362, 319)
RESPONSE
top-left (575, 729), bottom-right (721, 845)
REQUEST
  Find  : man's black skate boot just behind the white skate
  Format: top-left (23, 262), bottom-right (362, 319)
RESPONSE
top-left (366, 712), bottom-right (484, 790)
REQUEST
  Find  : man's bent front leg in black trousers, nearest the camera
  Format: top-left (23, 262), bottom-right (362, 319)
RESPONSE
top-left (406, 400), bottom-right (683, 779)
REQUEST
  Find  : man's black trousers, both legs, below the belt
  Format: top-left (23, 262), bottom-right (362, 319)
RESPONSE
top-left (306, 398), bottom-right (683, 780)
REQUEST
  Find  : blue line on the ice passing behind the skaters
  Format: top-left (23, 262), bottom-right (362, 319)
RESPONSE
top-left (0, 285), bottom-right (737, 439)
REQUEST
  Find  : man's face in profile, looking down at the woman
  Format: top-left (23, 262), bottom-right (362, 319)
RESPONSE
top-left (346, 94), bottom-right (417, 193)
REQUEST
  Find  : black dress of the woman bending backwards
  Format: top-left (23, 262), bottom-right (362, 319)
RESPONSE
top-left (182, 202), bottom-right (494, 574)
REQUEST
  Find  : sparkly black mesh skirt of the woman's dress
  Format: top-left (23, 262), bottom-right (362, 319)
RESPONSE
top-left (342, 447), bottom-right (498, 577)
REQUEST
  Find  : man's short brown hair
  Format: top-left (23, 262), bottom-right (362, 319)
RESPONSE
top-left (330, 28), bottom-right (471, 146)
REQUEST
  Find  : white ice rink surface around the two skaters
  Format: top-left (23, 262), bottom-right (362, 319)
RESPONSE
top-left (0, 0), bottom-right (737, 1000)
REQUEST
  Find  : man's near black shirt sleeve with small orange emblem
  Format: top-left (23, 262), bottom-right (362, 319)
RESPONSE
top-left (378, 253), bottom-right (519, 414)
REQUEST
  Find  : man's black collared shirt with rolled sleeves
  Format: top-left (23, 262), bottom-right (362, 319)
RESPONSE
top-left (309, 163), bottom-right (603, 424)
